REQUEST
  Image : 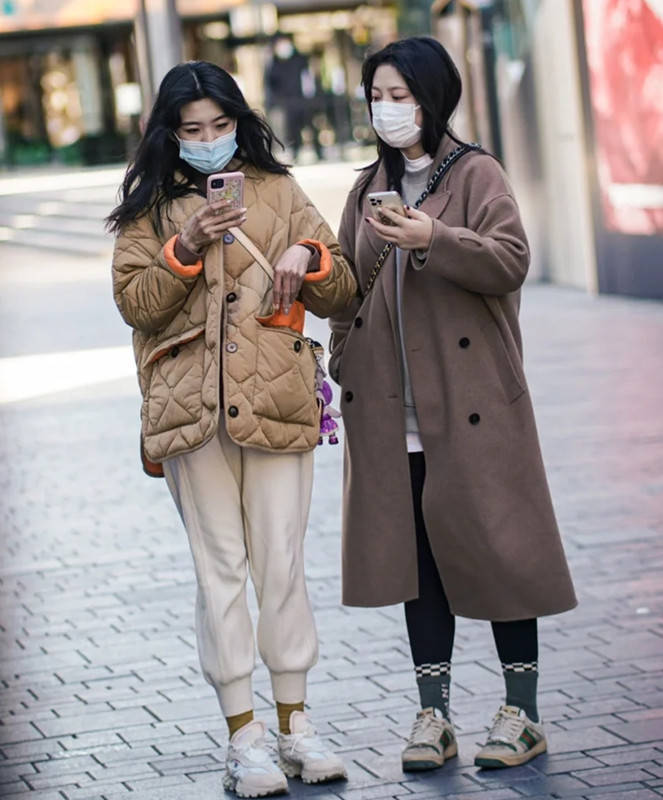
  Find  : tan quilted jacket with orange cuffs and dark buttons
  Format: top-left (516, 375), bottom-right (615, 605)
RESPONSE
top-left (113, 164), bottom-right (356, 462)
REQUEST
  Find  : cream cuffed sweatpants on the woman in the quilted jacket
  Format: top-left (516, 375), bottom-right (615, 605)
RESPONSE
top-left (163, 424), bottom-right (318, 717)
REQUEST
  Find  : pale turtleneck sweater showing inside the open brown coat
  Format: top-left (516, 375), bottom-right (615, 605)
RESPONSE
top-left (396, 153), bottom-right (433, 453)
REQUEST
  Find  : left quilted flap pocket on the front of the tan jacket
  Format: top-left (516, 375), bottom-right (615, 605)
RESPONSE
top-left (143, 325), bottom-right (206, 437)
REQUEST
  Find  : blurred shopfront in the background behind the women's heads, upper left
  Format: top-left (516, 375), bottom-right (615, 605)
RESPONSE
top-left (0, 0), bottom-right (398, 166)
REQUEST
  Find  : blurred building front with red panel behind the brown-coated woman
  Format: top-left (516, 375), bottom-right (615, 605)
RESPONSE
top-left (433, 0), bottom-right (663, 298)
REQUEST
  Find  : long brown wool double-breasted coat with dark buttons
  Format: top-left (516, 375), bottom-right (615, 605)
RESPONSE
top-left (330, 140), bottom-right (576, 621)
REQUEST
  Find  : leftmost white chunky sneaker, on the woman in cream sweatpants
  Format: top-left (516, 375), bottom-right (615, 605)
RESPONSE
top-left (223, 719), bottom-right (288, 797)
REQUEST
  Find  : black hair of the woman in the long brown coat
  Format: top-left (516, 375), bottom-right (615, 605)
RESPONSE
top-left (359, 36), bottom-right (462, 204)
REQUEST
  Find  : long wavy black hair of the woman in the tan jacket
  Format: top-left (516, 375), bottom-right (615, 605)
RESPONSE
top-left (106, 61), bottom-right (288, 232)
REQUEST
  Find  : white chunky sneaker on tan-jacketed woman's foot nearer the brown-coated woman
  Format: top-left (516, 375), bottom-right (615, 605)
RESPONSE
top-left (278, 711), bottom-right (348, 783)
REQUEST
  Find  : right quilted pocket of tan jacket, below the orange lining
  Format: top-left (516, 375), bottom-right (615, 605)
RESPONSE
top-left (252, 325), bottom-right (318, 426)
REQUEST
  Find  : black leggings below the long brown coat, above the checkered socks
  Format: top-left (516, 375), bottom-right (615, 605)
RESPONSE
top-left (405, 453), bottom-right (539, 665)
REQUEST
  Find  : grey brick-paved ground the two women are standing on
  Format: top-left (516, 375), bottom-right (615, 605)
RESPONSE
top-left (0, 286), bottom-right (663, 800)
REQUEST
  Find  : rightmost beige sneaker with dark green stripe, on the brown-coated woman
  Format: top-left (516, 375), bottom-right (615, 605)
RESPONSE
top-left (474, 706), bottom-right (547, 769)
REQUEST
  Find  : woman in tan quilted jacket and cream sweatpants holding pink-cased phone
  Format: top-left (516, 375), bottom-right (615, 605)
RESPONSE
top-left (108, 62), bottom-right (356, 797)
